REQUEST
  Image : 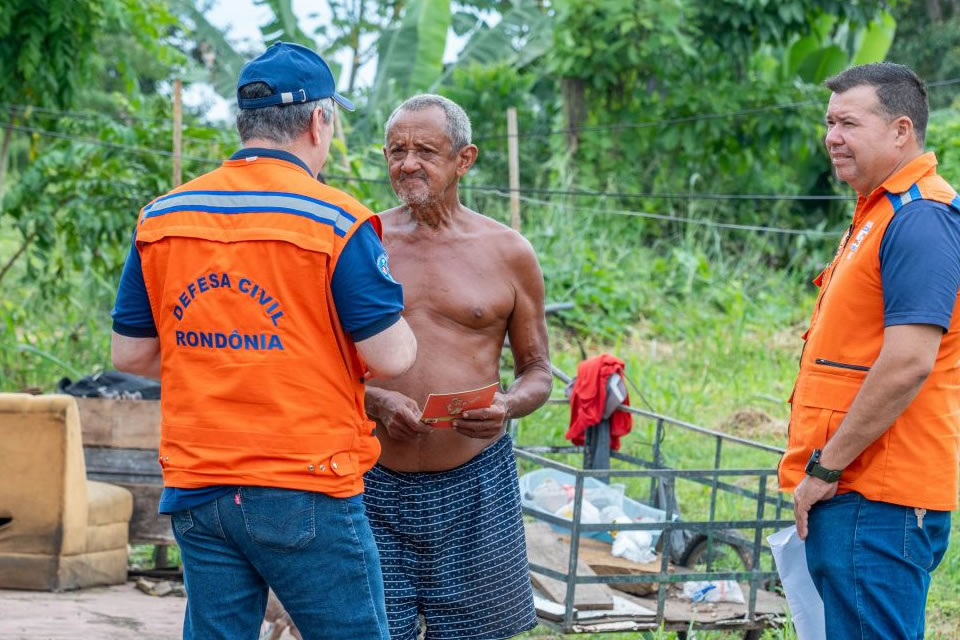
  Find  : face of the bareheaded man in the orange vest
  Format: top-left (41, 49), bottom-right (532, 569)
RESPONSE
top-left (824, 85), bottom-right (903, 194)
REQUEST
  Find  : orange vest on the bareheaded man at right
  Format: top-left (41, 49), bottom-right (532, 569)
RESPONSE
top-left (779, 153), bottom-right (960, 511)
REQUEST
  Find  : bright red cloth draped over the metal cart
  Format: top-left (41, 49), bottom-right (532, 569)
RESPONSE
top-left (566, 353), bottom-right (633, 451)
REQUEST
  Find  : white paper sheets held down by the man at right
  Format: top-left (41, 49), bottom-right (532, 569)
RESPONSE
top-left (767, 526), bottom-right (827, 640)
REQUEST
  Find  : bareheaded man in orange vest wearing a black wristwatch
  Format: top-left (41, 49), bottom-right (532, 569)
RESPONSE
top-left (780, 63), bottom-right (960, 639)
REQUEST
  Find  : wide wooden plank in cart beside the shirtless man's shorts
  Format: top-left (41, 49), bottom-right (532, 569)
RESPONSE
top-left (524, 522), bottom-right (613, 611)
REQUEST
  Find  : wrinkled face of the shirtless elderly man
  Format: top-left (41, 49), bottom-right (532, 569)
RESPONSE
top-left (383, 107), bottom-right (465, 206)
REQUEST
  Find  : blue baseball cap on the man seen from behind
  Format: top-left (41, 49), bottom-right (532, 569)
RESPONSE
top-left (237, 42), bottom-right (354, 111)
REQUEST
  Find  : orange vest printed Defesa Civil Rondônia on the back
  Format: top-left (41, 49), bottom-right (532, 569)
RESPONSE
top-left (136, 156), bottom-right (380, 497)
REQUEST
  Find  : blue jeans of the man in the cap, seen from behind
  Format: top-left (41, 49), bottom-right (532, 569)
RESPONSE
top-left (171, 487), bottom-right (390, 640)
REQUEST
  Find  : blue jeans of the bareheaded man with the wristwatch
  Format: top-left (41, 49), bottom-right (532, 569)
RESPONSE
top-left (806, 492), bottom-right (950, 640)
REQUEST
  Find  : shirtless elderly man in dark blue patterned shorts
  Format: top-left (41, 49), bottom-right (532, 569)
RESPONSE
top-left (364, 95), bottom-right (551, 640)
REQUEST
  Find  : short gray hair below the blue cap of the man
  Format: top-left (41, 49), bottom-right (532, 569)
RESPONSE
top-left (237, 82), bottom-right (334, 144)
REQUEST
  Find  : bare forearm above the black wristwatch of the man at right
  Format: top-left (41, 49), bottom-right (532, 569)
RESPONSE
top-left (820, 353), bottom-right (929, 469)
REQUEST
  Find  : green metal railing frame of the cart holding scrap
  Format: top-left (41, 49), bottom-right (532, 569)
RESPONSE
top-left (514, 366), bottom-right (793, 633)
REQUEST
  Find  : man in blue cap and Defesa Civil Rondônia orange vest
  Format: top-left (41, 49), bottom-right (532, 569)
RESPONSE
top-left (113, 43), bottom-right (416, 640)
